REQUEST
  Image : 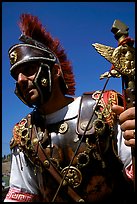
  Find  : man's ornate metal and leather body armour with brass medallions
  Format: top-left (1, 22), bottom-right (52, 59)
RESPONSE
top-left (11, 91), bottom-right (133, 203)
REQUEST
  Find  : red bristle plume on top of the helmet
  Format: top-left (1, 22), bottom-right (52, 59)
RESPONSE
top-left (19, 13), bottom-right (75, 95)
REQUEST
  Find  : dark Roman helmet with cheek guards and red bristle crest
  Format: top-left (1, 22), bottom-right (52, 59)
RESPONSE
top-left (9, 14), bottom-right (75, 107)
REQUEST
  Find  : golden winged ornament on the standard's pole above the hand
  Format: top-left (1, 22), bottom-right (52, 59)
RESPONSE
top-left (92, 43), bottom-right (135, 78)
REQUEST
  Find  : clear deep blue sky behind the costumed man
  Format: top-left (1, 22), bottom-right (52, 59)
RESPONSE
top-left (2, 2), bottom-right (135, 155)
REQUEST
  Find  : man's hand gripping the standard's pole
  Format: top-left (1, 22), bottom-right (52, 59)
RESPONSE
top-left (112, 105), bottom-right (135, 147)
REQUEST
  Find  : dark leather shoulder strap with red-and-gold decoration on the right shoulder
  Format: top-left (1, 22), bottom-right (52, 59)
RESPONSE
top-left (76, 90), bottom-right (123, 135)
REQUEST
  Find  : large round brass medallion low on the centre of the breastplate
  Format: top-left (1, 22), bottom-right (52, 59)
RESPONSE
top-left (61, 166), bottom-right (82, 188)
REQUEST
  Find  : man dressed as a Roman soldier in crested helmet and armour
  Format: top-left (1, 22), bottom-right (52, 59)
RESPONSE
top-left (4, 13), bottom-right (135, 204)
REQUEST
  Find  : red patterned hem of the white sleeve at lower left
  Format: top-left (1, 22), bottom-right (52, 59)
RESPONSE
top-left (5, 187), bottom-right (38, 202)
